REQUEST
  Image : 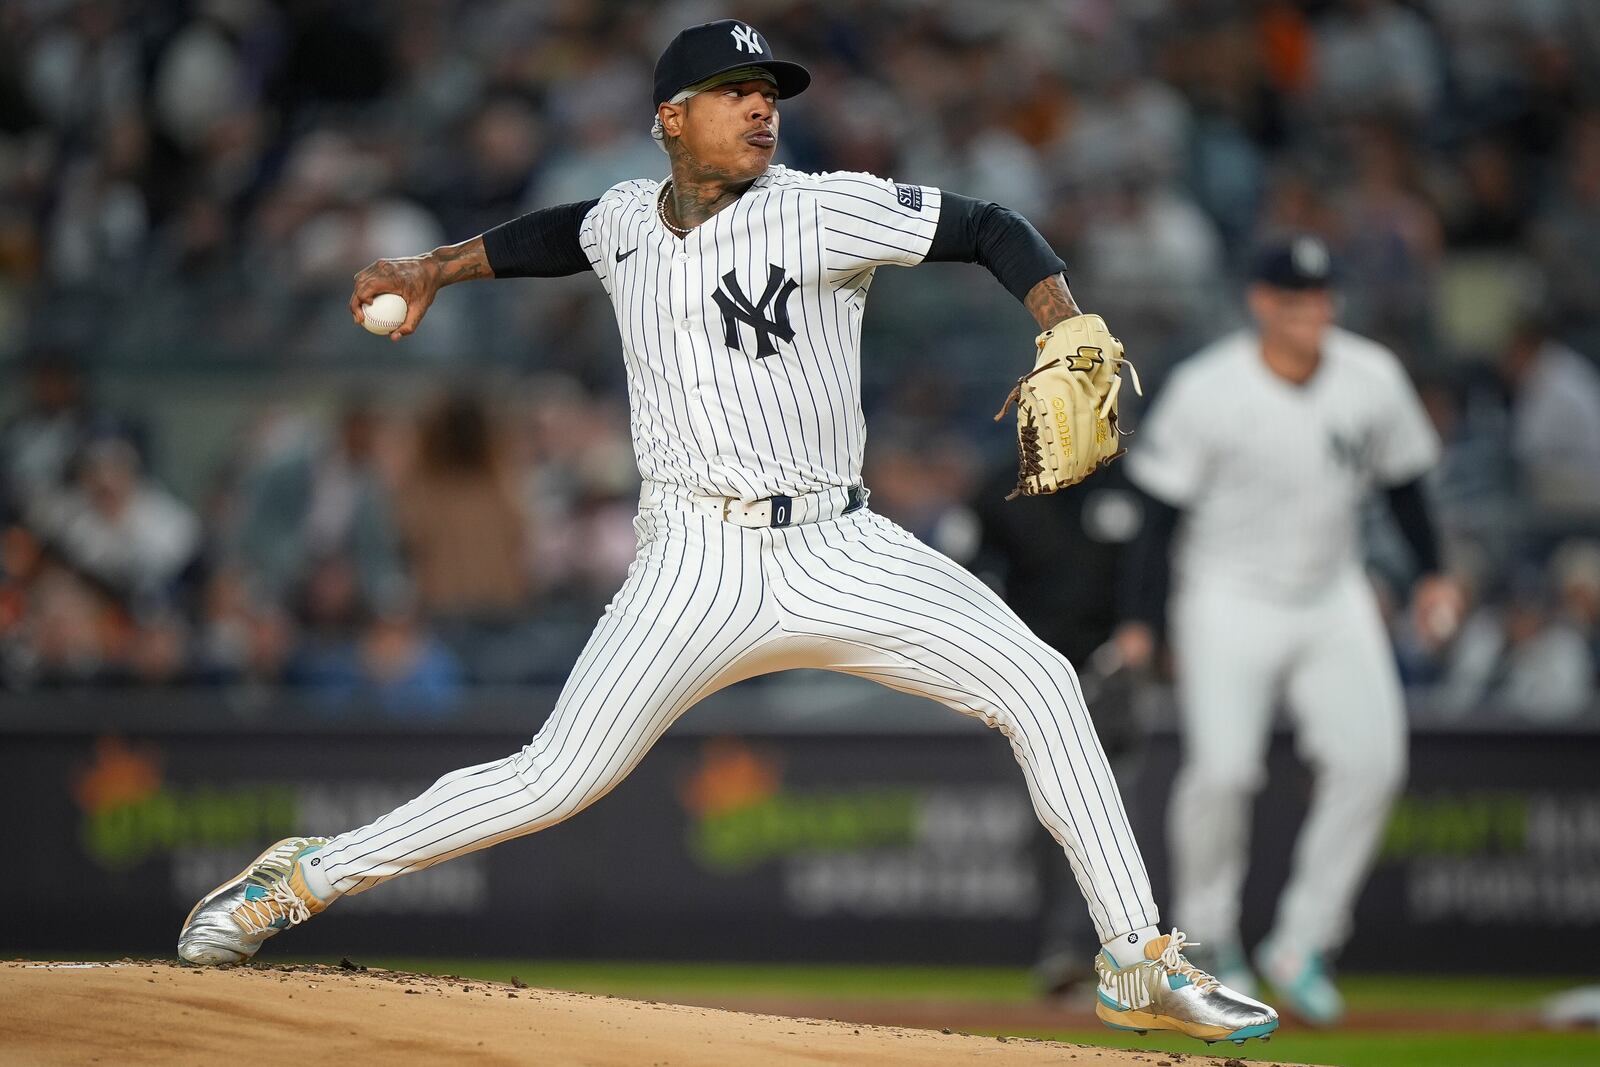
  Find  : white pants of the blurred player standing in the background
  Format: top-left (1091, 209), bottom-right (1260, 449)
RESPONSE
top-left (1166, 566), bottom-right (1406, 952)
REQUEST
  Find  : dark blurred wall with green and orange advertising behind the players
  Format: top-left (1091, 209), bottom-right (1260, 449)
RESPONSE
top-left (0, 713), bottom-right (1600, 969)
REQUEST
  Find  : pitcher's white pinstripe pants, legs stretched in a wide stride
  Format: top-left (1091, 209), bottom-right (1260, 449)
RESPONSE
top-left (323, 509), bottom-right (1158, 941)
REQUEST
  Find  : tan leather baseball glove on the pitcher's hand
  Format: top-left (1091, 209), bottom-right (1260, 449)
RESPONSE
top-left (995, 315), bottom-right (1144, 501)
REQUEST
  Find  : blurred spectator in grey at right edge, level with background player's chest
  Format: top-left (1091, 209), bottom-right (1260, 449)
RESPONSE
top-left (1501, 320), bottom-right (1600, 515)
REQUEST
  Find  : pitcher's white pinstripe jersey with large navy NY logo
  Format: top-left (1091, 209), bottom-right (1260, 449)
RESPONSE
top-left (579, 166), bottom-right (939, 501)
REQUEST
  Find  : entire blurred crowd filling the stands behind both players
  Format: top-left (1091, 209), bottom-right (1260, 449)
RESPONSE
top-left (0, 0), bottom-right (1600, 718)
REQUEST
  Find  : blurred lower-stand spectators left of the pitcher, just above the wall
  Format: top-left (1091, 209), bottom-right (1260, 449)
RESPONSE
top-left (0, 355), bottom-right (638, 713)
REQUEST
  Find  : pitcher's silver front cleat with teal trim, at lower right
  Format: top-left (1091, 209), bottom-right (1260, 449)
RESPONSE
top-left (1094, 929), bottom-right (1278, 1045)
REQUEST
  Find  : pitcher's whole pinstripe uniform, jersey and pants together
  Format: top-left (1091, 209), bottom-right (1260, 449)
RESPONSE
top-left (312, 168), bottom-right (1157, 939)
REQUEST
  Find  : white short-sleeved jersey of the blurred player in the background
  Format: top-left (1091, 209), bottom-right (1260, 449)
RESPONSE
top-left (1128, 328), bottom-right (1438, 598)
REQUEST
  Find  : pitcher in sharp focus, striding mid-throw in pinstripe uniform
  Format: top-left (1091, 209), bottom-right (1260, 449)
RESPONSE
top-left (178, 19), bottom-right (1278, 1041)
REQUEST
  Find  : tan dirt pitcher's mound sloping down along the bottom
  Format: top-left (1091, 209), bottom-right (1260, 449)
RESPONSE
top-left (0, 960), bottom-right (1299, 1067)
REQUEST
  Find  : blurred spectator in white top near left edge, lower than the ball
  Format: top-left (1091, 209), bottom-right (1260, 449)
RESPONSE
top-left (27, 437), bottom-right (200, 598)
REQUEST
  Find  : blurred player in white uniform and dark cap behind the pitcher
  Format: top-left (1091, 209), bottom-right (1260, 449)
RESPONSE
top-left (1117, 237), bottom-right (1459, 1025)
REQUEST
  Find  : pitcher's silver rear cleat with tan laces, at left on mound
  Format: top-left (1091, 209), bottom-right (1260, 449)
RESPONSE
top-left (178, 837), bottom-right (328, 965)
